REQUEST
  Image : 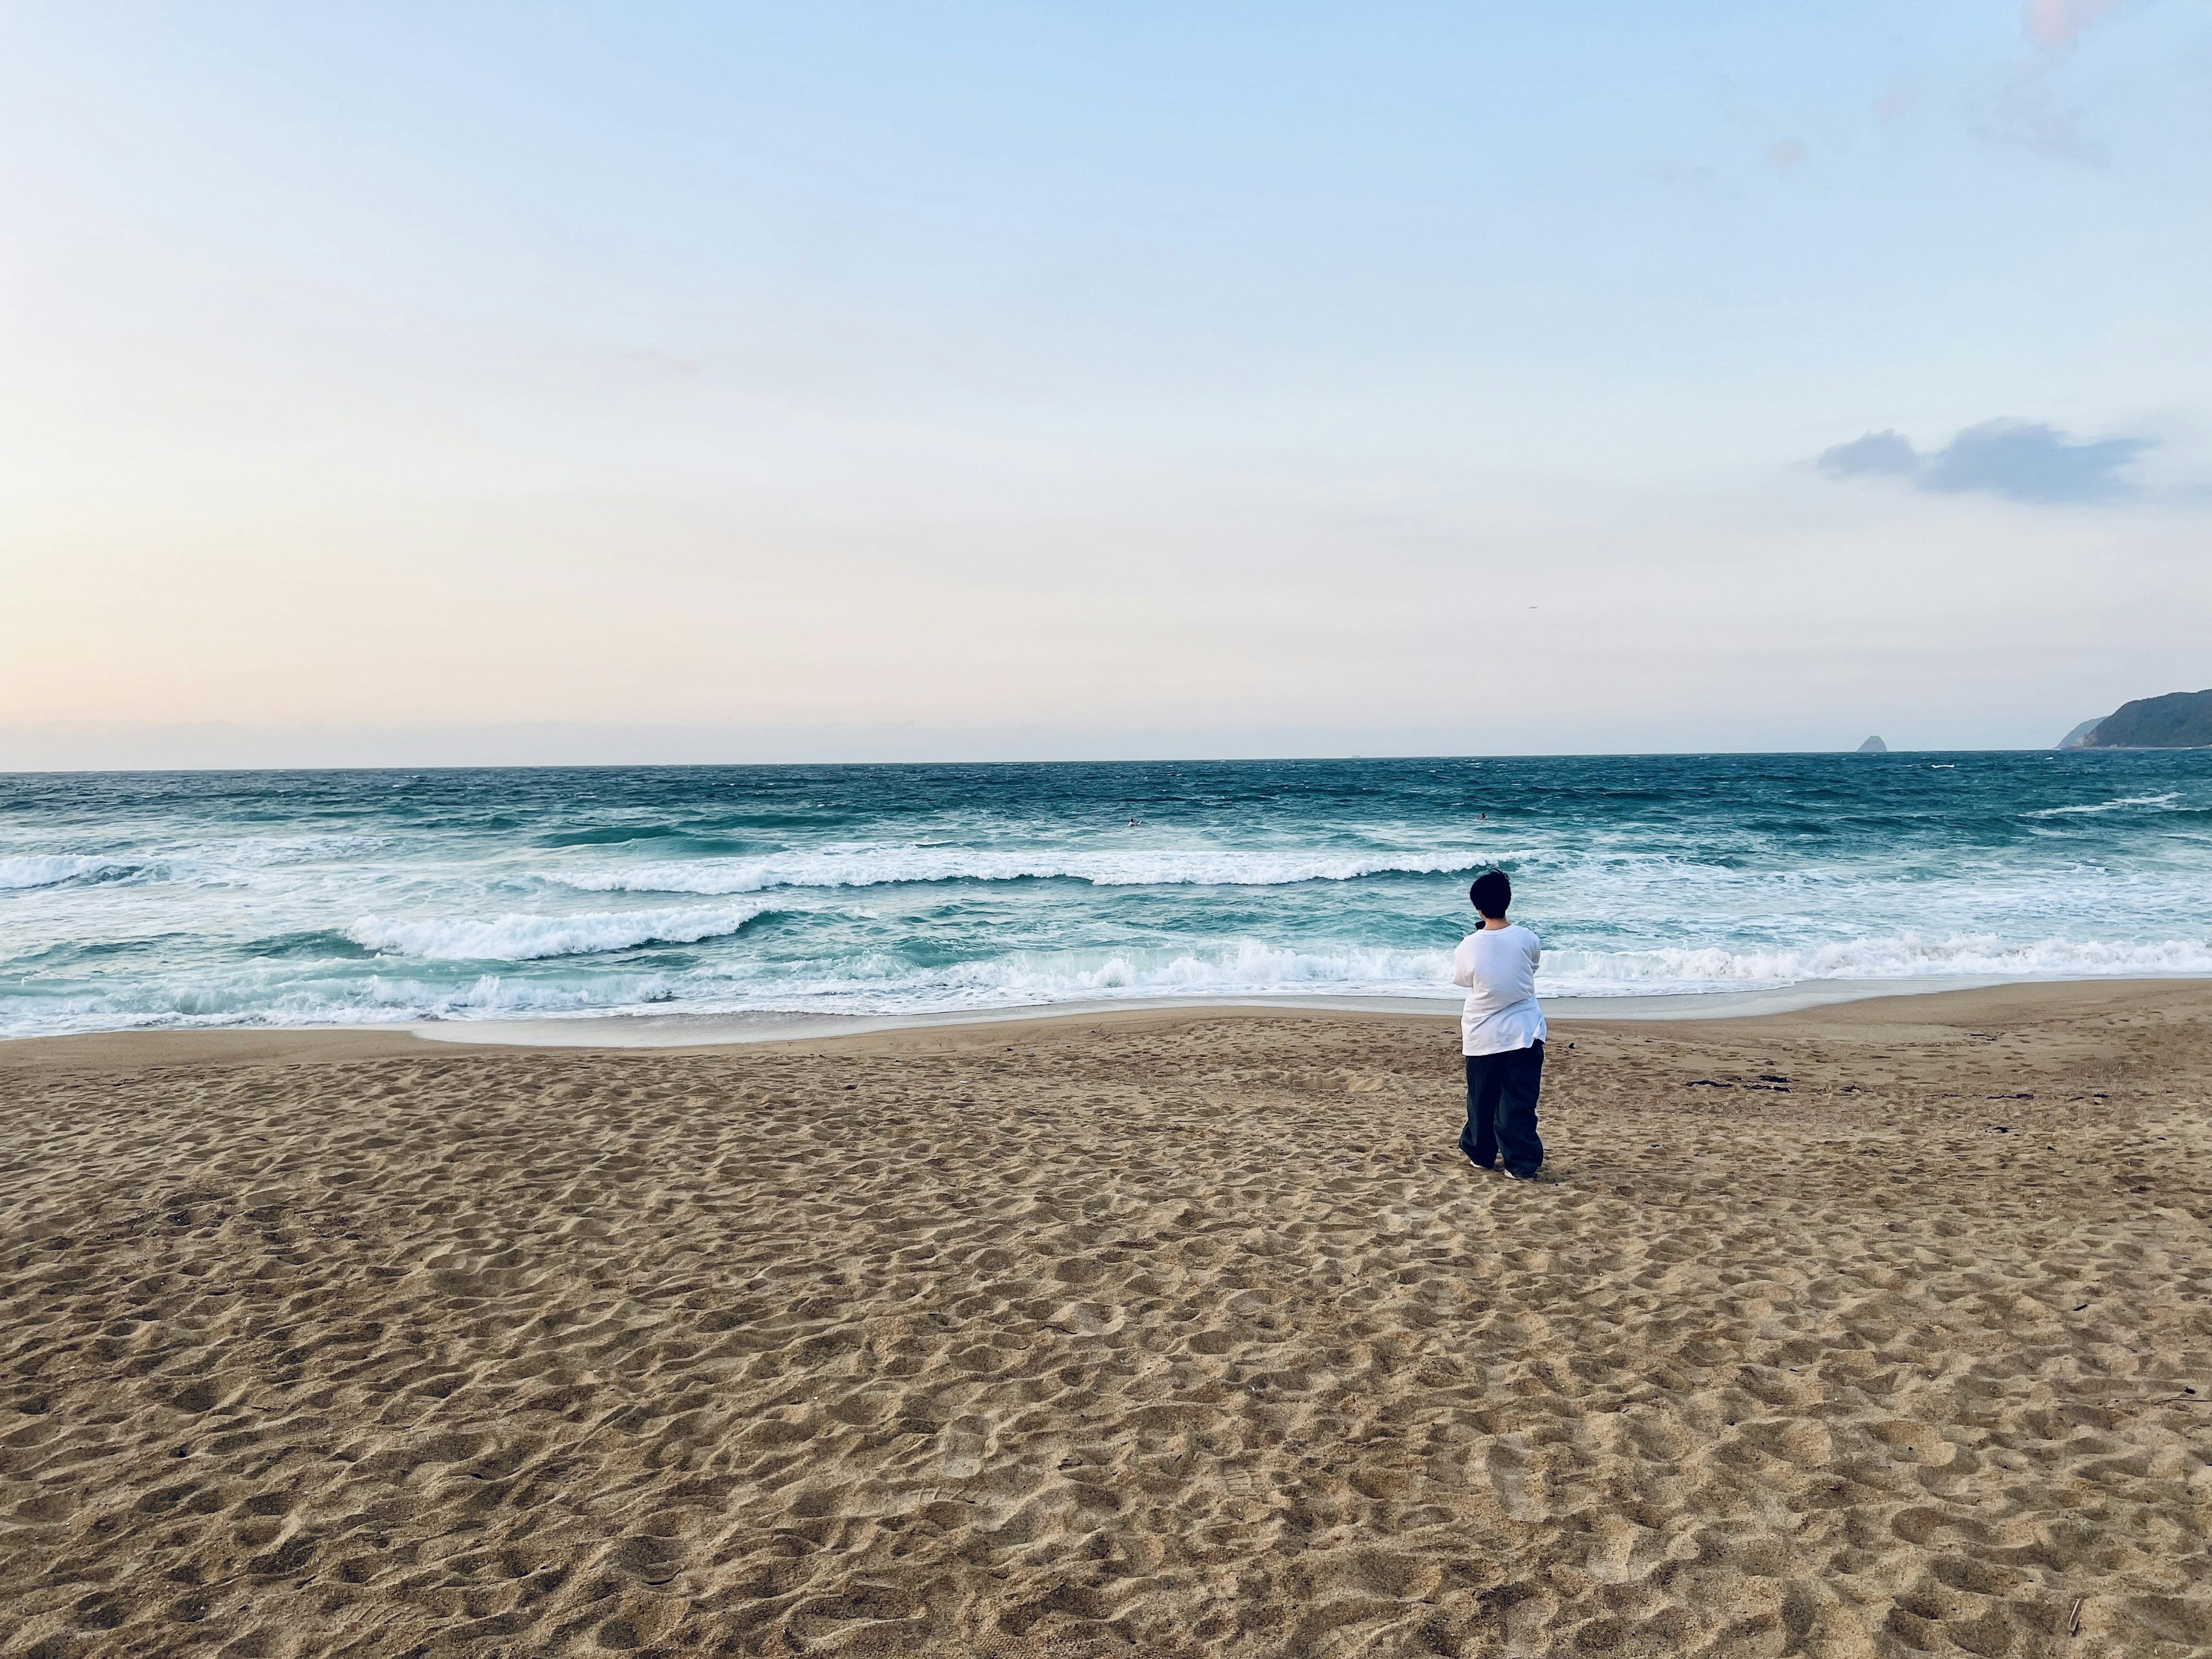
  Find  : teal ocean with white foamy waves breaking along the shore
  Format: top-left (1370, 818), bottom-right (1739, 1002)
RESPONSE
top-left (0, 752), bottom-right (2212, 1035)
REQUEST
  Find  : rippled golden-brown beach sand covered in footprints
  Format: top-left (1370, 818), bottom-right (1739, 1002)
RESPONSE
top-left (0, 982), bottom-right (2212, 1659)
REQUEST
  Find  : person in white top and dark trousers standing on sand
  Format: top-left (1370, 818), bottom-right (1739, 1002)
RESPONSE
top-left (1451, 869), bottom-right (1544, 1181)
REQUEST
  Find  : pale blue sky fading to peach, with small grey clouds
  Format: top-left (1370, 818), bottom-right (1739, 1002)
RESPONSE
top-left (0, 0), bottom-right (2212, 767)
